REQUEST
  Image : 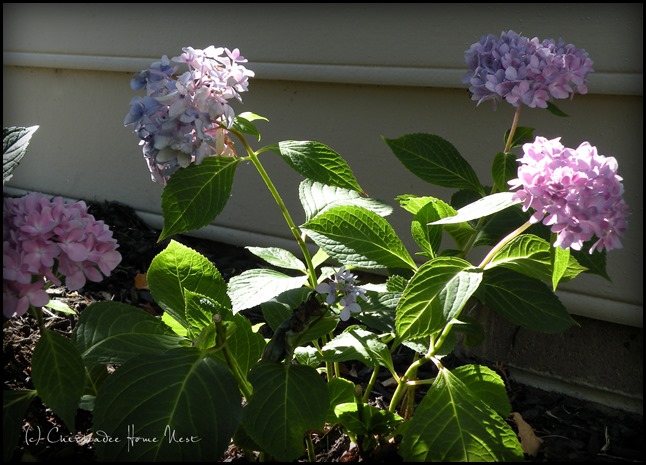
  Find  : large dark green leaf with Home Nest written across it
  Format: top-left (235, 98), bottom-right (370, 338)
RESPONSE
top-left (93, 347), bottom-right (242, 462)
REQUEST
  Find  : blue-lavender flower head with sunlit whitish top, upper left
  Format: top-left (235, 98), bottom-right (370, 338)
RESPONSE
top-left (124, 45), bottom-right (254, 184)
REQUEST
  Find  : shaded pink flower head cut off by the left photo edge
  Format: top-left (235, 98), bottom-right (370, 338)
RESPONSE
top-left (2, 193), bottom-right (121, 318)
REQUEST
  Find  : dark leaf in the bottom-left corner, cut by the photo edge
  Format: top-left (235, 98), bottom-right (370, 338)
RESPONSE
top-left (2, 389), bottom-right (36, 462)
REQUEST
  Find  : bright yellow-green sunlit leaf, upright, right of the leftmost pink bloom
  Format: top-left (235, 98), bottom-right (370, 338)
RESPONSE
top-left (146, 240), bottom-right (231, 328)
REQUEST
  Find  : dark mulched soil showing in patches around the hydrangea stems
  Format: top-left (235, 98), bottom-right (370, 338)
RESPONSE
top-left (3, 202), bottom-right (644, 462)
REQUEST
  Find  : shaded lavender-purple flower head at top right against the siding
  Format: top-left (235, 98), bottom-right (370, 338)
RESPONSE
top-left (463, 31), bottom-right (594, 108)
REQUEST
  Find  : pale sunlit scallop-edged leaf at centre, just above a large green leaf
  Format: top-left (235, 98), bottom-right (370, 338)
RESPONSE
top-left (298, 179), bottom-right (393, 221)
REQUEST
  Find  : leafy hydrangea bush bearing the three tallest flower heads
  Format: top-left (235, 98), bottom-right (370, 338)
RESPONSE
top-left (2, 31), bottom-right (628, 461)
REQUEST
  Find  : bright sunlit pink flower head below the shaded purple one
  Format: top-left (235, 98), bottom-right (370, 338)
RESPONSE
top-left (509, 137), bottom-right (628, 253)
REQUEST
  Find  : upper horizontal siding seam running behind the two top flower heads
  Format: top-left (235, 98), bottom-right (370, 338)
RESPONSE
top-left (3, 52), bottom-right (643, 96)
